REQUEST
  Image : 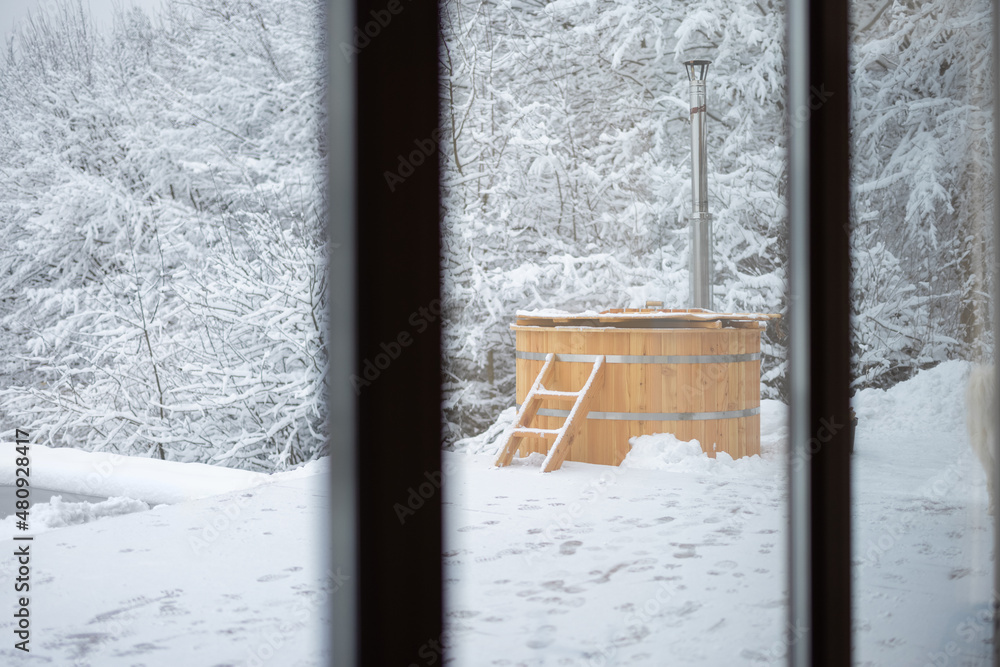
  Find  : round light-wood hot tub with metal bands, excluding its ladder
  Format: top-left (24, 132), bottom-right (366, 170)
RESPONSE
top-left (511, 309), bottom-right (775, 465)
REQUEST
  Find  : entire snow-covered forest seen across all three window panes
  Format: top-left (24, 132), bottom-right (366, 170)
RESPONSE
top-left (0, 0), bottom-right (994, 462)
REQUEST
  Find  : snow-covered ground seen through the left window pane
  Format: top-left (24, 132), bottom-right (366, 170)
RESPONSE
top-left (0, 452), bottom-right (332, 667)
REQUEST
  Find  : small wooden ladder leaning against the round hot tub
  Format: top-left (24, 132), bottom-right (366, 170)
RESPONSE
top-left (494, 352), bottom-right (604, 472)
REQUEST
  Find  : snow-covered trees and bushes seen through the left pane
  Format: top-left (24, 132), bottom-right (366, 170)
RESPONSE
top-left (0, 0), bottom-right (327, 472)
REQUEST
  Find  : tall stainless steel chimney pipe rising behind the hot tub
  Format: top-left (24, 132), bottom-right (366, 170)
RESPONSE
top-left (684, 60), bottom-right (713, 310)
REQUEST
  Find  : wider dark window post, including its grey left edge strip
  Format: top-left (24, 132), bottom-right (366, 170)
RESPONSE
top-left (326, 0), bottom-right (443, 666)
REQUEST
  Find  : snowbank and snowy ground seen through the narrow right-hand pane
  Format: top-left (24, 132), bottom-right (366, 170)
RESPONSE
top-left (854, 361), bottom-right (993, 665)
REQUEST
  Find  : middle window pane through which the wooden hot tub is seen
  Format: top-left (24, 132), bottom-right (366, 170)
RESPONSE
top-left (442, 0), bottom-right (796, 666)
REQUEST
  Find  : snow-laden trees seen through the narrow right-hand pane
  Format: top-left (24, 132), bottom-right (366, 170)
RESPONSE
top-left (852, 0), bottom-right (994, 386)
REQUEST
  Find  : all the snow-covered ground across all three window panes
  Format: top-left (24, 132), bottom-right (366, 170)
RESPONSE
top-left (0, 362), bottom-right (993, 667)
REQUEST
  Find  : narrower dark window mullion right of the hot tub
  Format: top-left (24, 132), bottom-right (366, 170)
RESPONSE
top-left (787, 0), bottom-right (851, 667)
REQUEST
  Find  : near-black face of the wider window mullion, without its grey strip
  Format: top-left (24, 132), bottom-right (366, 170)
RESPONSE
top-left (352, 0), bottom-right (445, 665)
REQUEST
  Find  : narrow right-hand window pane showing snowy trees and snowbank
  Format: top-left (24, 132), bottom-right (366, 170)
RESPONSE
top-left (850, 0), bottom-right (995, 665)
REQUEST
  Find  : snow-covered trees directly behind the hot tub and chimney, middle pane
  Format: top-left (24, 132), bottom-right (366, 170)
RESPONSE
top-left (441, 0), bottom-right (784, 438)
